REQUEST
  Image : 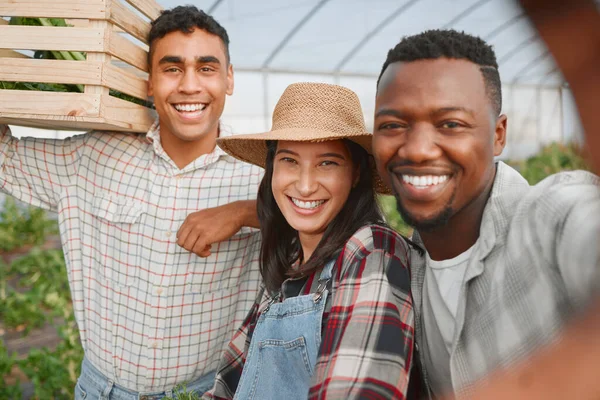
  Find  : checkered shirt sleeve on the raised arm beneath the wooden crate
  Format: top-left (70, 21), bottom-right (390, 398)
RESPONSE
top-left (0, 125), bottom-right (86, 210)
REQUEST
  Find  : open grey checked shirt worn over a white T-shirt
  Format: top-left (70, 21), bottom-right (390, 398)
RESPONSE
top-left (411, 162), bottom-right (600, 397)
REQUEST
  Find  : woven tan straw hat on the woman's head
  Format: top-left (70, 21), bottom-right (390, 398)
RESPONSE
top-left (217, 82), bottom-right (391, 194)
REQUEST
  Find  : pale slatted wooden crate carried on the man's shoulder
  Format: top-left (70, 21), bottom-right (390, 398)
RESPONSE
top-left (0, 0), bottom-right (161, 132)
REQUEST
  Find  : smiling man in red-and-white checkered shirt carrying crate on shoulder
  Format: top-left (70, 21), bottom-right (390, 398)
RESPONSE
top-left (0, 7), bottom-right (263, 398)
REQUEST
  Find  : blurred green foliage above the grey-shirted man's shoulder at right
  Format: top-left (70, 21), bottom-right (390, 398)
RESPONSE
top-left (508, 143), bottom-right (591, 185)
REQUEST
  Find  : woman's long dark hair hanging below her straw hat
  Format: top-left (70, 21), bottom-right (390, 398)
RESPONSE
top-left (257, 139), bottom-right (385, 293)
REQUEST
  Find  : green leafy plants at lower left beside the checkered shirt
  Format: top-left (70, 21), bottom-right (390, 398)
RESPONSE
top-left (0, 198), bottom-right (83, 399)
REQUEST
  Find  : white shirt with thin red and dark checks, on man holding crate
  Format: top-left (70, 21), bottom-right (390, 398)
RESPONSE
top-left (0, 124), bottom-right (263, 391)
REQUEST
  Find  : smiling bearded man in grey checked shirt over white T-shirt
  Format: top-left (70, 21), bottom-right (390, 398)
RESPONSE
top-left (373, 25), bottom-right (600, 399)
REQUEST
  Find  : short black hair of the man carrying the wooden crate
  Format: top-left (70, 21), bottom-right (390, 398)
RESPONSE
top-left (148, 5), bottom-right (230, 69)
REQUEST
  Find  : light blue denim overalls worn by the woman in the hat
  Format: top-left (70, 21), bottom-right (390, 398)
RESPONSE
top-left (234, 260), bottom-right (335, 400)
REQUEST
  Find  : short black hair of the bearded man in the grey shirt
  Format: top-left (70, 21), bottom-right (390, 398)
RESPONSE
top-left (377, 29), bottom-right (502, 115)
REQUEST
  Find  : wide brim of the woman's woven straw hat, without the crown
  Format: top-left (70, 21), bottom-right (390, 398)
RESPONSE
top-left (217, 128), bottom-right (392, 194)
